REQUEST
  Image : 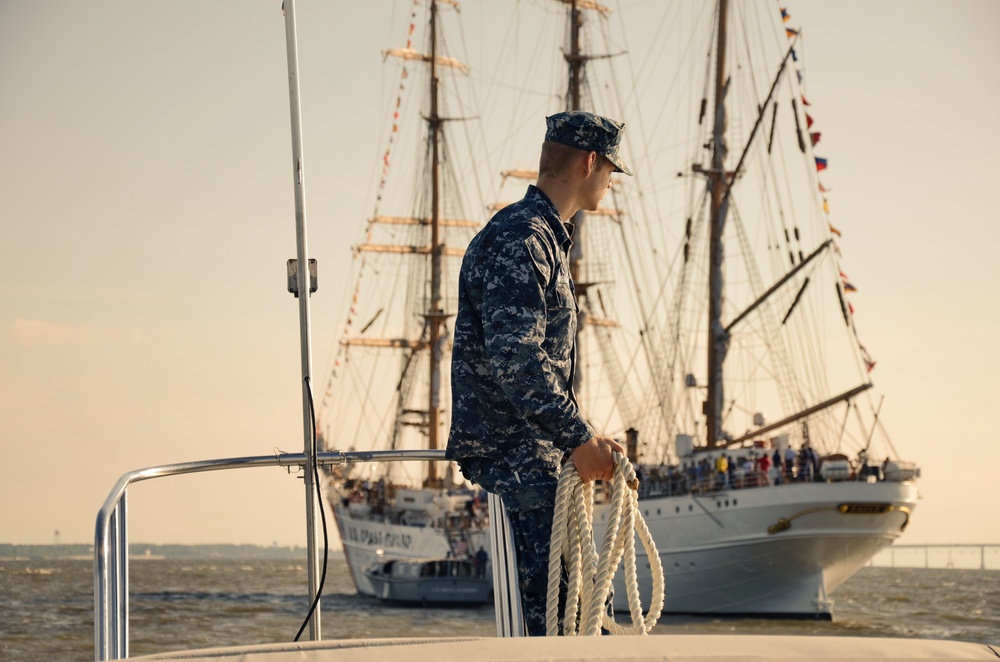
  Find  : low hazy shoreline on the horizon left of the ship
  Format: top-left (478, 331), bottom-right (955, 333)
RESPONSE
top-left (0, 543), bottom-right (344, 562)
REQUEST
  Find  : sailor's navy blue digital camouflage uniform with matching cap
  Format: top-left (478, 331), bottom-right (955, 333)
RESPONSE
top-left (447, 111), bottom-right (631, 636)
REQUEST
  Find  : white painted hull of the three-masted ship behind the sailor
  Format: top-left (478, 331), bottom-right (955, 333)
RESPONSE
top-left (336, 481), bottom-right (918, 619)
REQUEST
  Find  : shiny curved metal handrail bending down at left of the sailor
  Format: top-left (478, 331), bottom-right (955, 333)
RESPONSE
top-left (94, 450), bottom-right (445, 660)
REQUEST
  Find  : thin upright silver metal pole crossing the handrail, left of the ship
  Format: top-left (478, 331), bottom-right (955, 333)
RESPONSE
top-left (284, 0), bottom-right (322, 641)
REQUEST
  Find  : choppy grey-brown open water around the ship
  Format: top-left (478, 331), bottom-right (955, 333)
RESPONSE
top-left (0, 559), bottom-right (1000, 662)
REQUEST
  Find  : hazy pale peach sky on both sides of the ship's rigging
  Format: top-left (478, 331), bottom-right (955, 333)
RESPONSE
top-left (0, 0), bottom-right (1000, 545)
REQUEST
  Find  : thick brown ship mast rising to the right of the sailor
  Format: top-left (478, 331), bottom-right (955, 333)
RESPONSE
top-left (704, 0), bottom-right (729, 448)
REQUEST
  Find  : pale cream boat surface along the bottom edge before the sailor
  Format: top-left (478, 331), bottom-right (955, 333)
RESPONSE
top-left (132, 635), bottom-right (1000, 662)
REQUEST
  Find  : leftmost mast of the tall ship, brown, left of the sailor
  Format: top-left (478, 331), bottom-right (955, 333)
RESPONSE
top-left (425, 0), bottom-right (446, 486)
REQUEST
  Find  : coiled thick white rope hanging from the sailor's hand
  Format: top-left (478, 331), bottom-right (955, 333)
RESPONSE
top-left (545, 453), bottom-right (664, 637)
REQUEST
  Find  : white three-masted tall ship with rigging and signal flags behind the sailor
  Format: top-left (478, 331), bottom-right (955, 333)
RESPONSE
top-left (321, 0), bottom-right (919, 618)
